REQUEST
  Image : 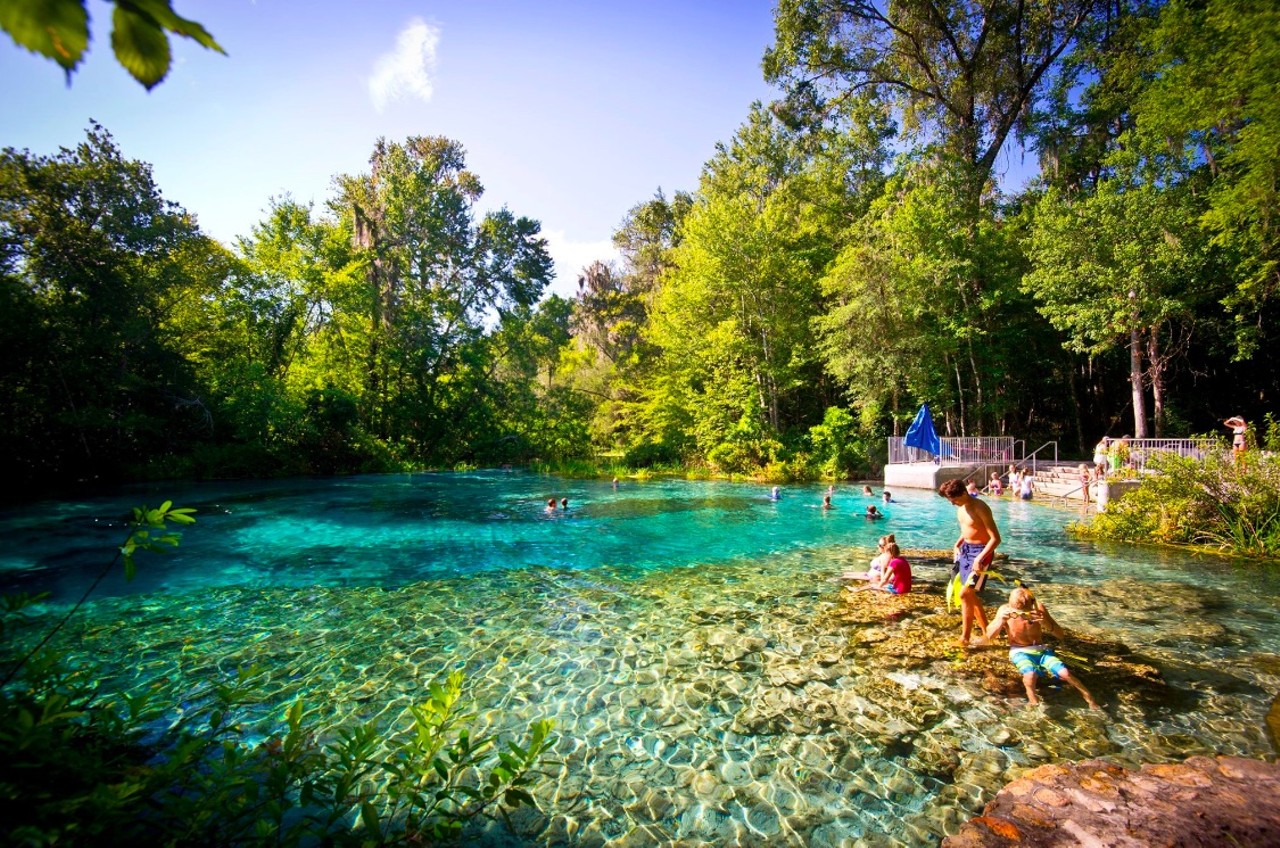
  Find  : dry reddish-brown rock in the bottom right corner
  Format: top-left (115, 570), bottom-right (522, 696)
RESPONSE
top-left (942, 757), bottom-right (1280, 848)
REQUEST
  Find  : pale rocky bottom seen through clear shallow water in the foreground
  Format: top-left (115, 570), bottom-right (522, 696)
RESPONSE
top-left (12, 548), bottom-right (1280, 848)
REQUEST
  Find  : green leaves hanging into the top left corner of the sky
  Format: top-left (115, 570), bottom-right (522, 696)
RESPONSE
top-left (0, 0), bottom-right (227, 91)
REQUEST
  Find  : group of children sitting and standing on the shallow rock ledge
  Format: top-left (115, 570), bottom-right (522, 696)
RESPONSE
top-left (844, 480), bottom-right (1100, 710)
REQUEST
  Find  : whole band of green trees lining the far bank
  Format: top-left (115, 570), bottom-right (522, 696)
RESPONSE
top-left (0, 0), bottom-right (1280, 484)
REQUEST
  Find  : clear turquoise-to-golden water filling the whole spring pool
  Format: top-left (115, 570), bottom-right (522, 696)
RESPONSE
top-left (0, 471), bottom-right (1280, 844)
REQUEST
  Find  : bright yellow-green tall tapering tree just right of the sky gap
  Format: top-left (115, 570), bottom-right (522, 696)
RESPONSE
top-left (649, 105), bottom-right (832, 470)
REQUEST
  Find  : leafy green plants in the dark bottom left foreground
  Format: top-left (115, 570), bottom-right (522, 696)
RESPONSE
top-left (0, 502), bottom-right (556, 845)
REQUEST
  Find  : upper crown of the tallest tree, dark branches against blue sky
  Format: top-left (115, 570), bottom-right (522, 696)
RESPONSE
top-left (764, 0), bottom-right (1101, 190)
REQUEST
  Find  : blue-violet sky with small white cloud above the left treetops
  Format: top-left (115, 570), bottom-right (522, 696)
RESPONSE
top-left (0, 0), bottom-right (773, 295)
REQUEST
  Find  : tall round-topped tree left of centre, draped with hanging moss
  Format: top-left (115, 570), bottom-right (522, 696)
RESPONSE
top-left (334, 137), bottom-right (552, 456)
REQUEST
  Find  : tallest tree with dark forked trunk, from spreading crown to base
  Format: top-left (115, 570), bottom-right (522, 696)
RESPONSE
top-left (764, 0), bottom-right (1116, 432)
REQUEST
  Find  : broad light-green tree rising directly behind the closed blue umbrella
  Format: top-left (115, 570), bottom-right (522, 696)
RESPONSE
top-left (817, 158), bottom-right (1025, 436)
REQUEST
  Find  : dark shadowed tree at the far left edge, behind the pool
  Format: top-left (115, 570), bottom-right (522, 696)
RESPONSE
top-left (0, 124), bottom-right (227, 484)
